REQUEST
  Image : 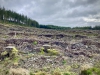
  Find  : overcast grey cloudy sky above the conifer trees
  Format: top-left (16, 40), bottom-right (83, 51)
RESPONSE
top-left (0, 0), bottom-right (100, 27)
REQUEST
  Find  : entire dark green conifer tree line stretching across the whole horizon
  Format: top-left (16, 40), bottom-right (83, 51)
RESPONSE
top-left (0, 7), bottom-right (100, 30)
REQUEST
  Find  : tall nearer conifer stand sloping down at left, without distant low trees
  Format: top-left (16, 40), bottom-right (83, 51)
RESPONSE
top-left (0, 7), bottom-right (39, 27)
